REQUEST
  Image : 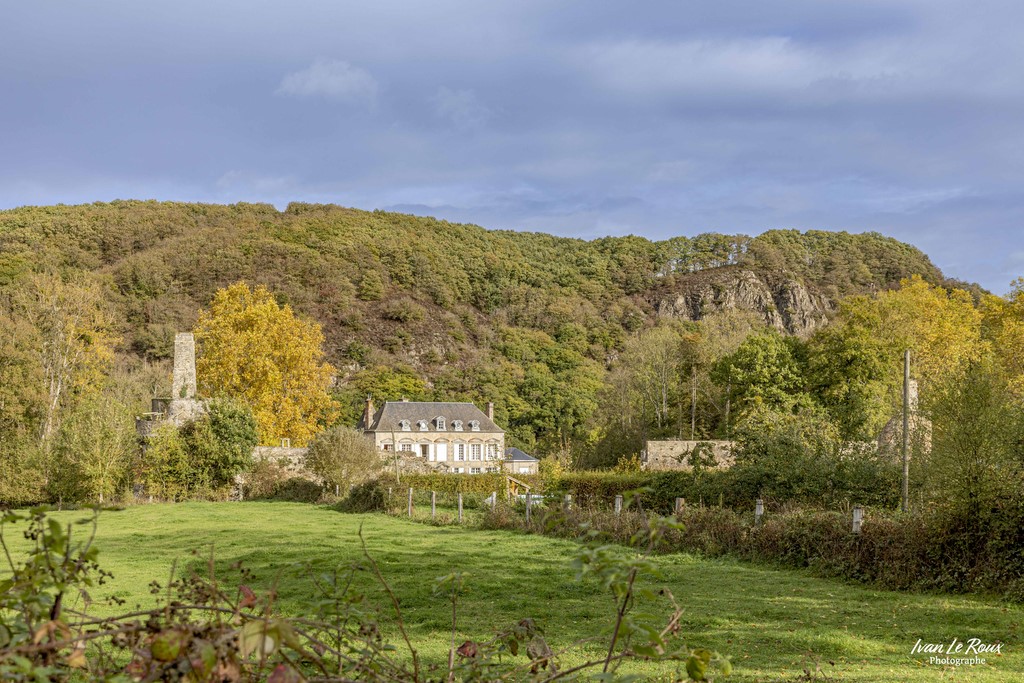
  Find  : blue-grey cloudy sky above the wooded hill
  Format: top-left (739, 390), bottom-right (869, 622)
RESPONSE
top-left (0, 0), bottom-right (1024, 294)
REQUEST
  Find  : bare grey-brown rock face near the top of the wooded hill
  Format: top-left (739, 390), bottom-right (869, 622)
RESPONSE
top-left (653, 269), bottom-right (833, 335)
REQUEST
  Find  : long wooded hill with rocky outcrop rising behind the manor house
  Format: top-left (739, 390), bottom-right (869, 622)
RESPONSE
top-left (0, 201), bottom-right (943, 450)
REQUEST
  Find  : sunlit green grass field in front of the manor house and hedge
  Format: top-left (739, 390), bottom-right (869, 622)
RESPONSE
top-left (5, 503), bottom-right (1024, 681)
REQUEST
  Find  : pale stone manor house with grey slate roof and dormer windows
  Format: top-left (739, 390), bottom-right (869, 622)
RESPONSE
top-left (357, 398), bottom-right (538, 474)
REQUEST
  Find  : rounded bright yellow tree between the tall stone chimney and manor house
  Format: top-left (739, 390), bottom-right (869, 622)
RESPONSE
top-left (196, 283), bottom-right (338, 445)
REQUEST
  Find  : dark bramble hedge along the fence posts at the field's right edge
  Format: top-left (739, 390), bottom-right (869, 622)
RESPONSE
top-left (480, 492), bottom-right (1024, 601)
